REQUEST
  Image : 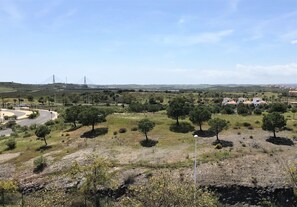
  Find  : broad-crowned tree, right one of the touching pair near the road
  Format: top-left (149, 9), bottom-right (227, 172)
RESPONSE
top-left (78, 107), bottom-right (107, 131)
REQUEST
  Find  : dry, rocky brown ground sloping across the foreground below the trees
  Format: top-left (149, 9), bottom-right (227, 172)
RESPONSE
top-left (0, 129), bottom-right (297, 206)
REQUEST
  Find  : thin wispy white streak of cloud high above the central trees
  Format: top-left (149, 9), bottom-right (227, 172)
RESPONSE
top-left (162, 29), bottom-right (233, 46)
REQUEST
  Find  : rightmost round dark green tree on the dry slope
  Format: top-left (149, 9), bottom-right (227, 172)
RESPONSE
top-left (262, 112), bottom-right (287, 138)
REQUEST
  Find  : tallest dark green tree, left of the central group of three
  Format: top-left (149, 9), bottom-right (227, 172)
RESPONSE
top-left (167, 97), bottom-right (191, 126)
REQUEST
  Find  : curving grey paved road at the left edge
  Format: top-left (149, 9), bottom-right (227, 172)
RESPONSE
top-left (0, 110), bottom-right (58, 136)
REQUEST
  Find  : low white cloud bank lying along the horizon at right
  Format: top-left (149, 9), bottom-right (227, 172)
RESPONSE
top-left (162, 63), bottom-right (297, 84)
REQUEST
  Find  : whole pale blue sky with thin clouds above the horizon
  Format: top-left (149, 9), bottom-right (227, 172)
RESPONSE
top-left (0, 0), bottom-right (297, 84)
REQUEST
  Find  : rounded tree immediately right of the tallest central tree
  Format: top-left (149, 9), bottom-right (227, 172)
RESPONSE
top-left (190, 106), bottom-right (211, 131)
